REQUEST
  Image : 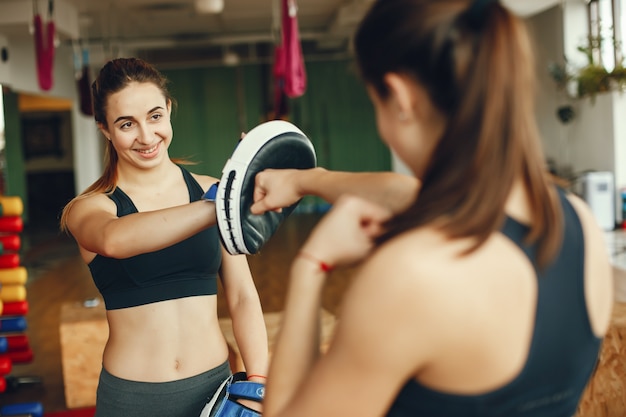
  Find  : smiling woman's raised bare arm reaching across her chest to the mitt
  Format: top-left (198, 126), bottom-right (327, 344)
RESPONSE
top-left (68, 194), bottom-right (216, 258)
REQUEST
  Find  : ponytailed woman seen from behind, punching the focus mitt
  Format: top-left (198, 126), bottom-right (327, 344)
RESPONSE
top-left (253, 0), bottom-right (613, 417)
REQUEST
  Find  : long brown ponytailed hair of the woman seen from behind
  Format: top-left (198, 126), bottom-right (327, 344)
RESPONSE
top-left (355, 0), bottom-right (562, 266)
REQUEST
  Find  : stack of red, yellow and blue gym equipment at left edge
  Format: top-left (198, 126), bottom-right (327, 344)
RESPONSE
top-left (0, 196), bottom-right (43, 417)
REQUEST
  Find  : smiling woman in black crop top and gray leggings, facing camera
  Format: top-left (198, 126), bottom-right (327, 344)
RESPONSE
top-left (61, 58), bottom-right (268, 417)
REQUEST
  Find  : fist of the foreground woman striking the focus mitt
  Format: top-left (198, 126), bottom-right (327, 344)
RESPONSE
top-left (250, 169), bottom-right (302, 214)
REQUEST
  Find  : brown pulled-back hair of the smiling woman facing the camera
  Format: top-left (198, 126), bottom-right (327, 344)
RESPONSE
top-left (60, 58), bottom-right (179, 232)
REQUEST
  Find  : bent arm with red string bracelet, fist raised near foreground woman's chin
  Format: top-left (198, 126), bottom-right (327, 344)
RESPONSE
top-left (263, 198), bottom-right (432, 417)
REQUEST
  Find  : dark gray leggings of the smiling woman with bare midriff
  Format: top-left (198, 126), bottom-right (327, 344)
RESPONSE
top-left (94, 362), bottom-right (230, 417)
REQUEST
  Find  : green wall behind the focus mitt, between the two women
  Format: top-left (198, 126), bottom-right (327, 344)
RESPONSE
top-left (163, 60), bottom-right (391, 177)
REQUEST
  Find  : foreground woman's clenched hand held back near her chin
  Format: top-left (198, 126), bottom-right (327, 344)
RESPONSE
top-left (302, 195), bottom-right (392, 267)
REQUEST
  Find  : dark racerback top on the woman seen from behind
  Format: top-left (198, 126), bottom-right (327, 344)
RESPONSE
top-left (387, 189), bottom-right (601, 417)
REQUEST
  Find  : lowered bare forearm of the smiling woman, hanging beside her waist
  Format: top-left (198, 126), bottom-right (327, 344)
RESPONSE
top-left (220, 250), bottom-right (269, 376)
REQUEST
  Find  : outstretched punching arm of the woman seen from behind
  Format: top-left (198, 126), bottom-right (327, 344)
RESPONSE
top-left (251, 168), bottom-right (420, 214)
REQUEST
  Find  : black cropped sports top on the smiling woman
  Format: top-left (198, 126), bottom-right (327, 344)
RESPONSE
top-left (89, 167), bottom-right (222, 310)
